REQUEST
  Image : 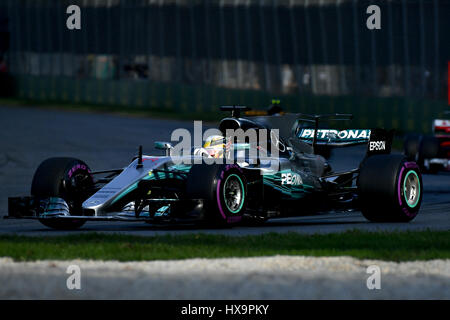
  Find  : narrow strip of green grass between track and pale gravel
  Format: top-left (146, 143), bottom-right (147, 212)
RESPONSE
top-left (0, 230), bottom-right (450, 261)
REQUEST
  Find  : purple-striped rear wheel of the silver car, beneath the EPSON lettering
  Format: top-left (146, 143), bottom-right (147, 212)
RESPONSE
top-left (357, 155), bottom-right (423, 222)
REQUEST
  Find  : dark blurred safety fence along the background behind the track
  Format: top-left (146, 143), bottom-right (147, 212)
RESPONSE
top-left (0, 0), bottom-right (450, 131)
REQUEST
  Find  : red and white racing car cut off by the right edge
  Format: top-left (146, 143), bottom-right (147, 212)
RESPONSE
top-left (404, 111), bottom-right (450, 173)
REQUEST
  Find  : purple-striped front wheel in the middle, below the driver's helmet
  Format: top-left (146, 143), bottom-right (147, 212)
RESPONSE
top-left (186, 163), bottom-right (247, 226)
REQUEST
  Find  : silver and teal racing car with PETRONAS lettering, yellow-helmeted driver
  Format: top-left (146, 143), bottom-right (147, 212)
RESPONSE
top-left (7, 106), bottom-right (423, 229)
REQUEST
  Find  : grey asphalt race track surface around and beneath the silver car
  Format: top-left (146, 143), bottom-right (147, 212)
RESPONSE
top-left (0, 106), bottom-right (450, 236)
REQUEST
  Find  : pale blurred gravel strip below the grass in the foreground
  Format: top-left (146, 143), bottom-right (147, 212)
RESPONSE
top-left (0, 256), bottom-right (450, 299)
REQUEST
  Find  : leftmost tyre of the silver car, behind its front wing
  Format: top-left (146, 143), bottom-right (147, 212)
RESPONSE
top-left (31, 158), bottom-right (93, 230)
